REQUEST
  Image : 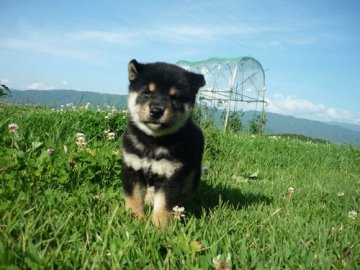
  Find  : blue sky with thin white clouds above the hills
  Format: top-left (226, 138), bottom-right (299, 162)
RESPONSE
top-left (0, 0), bottom-right (360, 125)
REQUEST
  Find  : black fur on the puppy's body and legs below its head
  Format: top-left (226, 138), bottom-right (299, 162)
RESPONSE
top-left (121, 121), bottom-right (204, 206)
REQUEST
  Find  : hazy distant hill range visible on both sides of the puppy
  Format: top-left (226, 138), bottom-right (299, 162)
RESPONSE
top-left (6, 90), bottom-right (360, 145)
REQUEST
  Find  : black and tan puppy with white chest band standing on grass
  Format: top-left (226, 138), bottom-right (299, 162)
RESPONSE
top-left (121, 60), bottom-right (205, 227)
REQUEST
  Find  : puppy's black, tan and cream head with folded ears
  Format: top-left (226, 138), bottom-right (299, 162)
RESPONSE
top-left (128, 60), bottom-right (205, 137)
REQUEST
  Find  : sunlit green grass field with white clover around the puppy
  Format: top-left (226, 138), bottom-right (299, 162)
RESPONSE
top-left (0, 103), bottom-right (360, 269)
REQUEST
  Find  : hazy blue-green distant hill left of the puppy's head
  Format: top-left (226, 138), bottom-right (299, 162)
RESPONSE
top-left (6, 90), bottom-right (127, 108)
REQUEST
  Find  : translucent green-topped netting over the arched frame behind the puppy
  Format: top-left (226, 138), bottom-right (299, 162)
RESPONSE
top-left (177, 57), bottom-right (265, 111)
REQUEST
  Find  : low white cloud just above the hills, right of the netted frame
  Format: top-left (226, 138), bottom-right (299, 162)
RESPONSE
top-left (267, 94), bottom-right (360, 124)
